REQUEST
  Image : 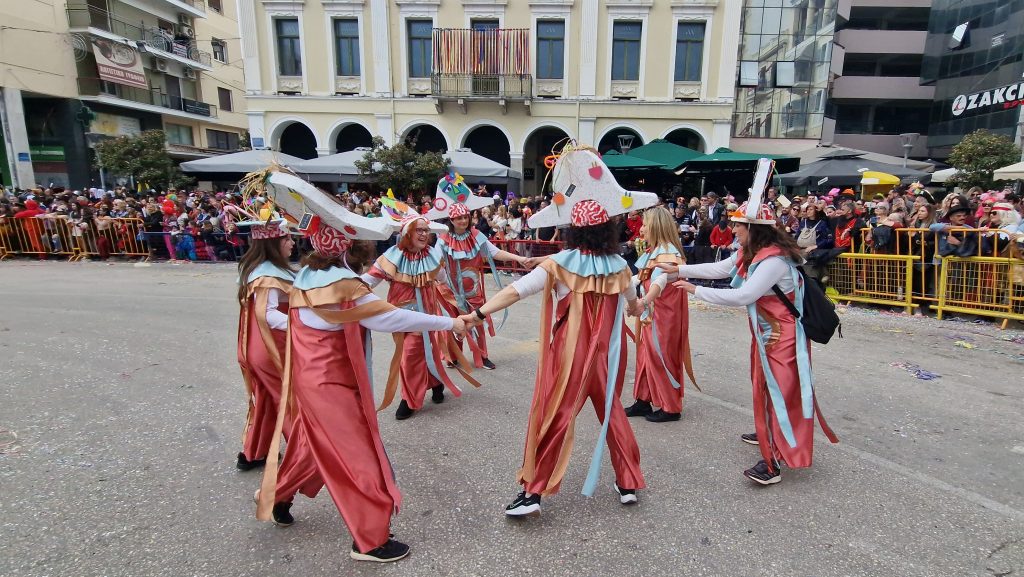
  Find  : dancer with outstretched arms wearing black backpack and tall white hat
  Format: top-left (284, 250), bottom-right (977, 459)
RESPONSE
top-left (658, 159), bottom-right (839, 485)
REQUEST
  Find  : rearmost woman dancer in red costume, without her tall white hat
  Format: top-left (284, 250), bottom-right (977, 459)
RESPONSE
top-left (435, 203), bottom-right (530, 370)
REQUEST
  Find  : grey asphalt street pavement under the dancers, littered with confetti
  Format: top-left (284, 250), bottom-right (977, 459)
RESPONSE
top-left (0, 260), bottom-right (1024, 577)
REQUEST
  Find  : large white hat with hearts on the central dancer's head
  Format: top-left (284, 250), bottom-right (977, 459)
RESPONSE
top-left (528, 142), bottom-right (658, 229)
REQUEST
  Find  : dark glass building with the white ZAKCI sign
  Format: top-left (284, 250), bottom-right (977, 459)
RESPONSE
top-left (922, 0), bottom-right (1024, 158)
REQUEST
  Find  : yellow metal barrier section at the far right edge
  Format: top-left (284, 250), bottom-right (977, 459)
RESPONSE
top-left (932, 256), bottom-right (1024, 328)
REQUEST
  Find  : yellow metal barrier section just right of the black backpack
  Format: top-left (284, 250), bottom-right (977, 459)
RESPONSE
top-left (828, 252), bottom-right (915, 314)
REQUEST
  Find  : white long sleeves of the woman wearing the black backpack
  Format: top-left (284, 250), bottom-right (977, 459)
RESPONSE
top-left (679, 254), bottom-right (796, 306)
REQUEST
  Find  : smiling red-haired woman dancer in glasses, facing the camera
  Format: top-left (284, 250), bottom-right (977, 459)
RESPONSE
top-left (362, 191), bottom-right (480, 420)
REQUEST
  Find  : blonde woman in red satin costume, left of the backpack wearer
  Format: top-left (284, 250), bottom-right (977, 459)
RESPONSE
top-left (626, 207), bottom-right (696, 422)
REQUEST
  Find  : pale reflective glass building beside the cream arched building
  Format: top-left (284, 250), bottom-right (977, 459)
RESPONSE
top-left (732, 0), bottom-right (838, 139)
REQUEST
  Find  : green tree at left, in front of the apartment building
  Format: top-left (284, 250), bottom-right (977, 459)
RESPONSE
top-left (96, 130), bottom-right (193, 188)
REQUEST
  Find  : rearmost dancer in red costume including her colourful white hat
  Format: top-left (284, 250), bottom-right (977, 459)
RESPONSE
top-left (427, 172), bottom-right (531, 370)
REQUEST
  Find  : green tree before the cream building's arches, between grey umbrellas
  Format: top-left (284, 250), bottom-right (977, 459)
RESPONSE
top-left (355, 136), bottom-right (451, 198)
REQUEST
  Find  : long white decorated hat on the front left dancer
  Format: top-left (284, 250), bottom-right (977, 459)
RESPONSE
top-left (244, 167), bottom-right (391, 241)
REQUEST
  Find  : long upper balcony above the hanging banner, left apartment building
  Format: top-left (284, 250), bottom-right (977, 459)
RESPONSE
top-left (66, 4), bottom-right (213, 72)
